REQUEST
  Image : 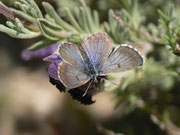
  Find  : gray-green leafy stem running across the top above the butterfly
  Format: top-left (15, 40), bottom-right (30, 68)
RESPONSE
top-left (0, 0), bottom-right (179, 55)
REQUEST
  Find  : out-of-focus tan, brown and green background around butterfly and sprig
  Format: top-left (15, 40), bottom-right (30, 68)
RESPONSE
top-left (0, 0), bottom-right (180, 135)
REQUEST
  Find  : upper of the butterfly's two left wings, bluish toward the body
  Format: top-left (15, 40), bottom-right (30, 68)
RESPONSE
top-left (59, 42), bottom-right (84, 69)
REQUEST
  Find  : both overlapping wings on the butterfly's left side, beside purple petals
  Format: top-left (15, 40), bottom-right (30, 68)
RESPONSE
top-left (58, 42), bottom-right (90, 89)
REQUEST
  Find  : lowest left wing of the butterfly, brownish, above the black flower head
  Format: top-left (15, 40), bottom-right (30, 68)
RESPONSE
top-left (58, 62), bottom-right (90, 89)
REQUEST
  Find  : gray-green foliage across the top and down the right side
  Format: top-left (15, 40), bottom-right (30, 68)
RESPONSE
top-left (0, 0), bottom-right (180, 134)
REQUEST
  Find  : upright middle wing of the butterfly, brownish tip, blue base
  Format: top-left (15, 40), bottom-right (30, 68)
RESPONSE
top-left (82, 33), bottom-right (112, 69)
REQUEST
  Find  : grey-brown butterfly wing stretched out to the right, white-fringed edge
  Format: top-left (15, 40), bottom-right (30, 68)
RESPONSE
top-left (100, 45), bottom-right (144, 74)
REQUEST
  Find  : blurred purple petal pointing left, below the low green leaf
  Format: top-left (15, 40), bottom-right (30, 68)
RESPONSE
top-left (21, 44), bottom-right (58, 61)
